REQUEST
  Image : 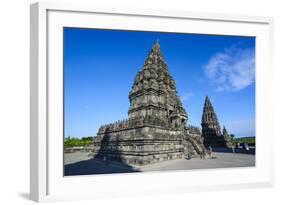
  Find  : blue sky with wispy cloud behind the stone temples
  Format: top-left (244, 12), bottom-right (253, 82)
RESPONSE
top-left (64, 28), bottom-right (255, 137)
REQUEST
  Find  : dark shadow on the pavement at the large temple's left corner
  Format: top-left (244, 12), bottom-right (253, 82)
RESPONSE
top-left (64, 159), bottom-right (139, 176)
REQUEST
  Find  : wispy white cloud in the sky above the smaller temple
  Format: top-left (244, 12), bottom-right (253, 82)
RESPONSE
top-left (203, 46), bottom-right (255, 91)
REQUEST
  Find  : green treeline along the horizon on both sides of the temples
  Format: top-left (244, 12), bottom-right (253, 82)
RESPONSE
top-left (64, 136), bottom-right (256, 147)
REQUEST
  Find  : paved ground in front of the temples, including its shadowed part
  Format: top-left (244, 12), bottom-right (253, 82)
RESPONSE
top-left (64, 152), bottom-right (255, 176)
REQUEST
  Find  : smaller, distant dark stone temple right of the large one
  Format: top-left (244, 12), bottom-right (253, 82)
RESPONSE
top-left (201, 96), bottom-right (232, 147)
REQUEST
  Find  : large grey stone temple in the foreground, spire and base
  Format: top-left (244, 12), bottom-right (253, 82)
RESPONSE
top-left (93, 42), bottom-right (210, 165)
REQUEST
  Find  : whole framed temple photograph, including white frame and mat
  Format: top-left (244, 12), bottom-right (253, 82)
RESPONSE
top-left (30, 3), bottom-right (273, 201)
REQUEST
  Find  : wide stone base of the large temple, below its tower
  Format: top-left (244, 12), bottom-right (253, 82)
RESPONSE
top-left (92, 123), bottom-right (209, 165)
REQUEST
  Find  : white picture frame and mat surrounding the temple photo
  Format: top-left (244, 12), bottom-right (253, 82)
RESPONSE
top-left (30, 2), bottom-right (274, 202)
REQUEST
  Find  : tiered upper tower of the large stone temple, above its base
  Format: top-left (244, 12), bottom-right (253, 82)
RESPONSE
top-left (128, 39), bottom-right (188, 124)
